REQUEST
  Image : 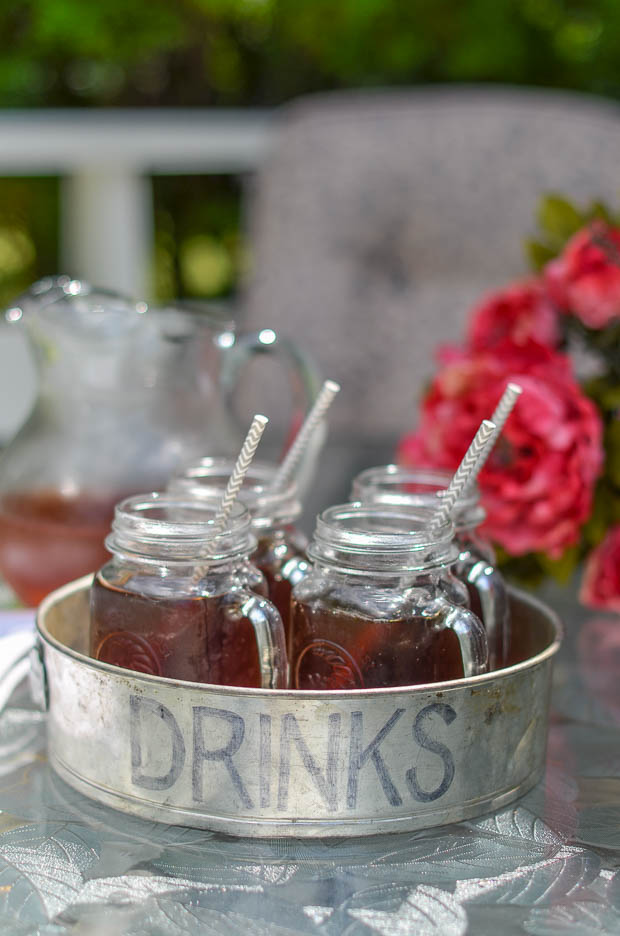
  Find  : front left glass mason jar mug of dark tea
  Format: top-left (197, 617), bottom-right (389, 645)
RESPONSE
top-left (90, 493), bottom-right (287, 688)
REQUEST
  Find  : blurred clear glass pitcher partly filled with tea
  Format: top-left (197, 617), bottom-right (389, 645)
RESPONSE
top-left (0, 277), bottom-right (320, 605)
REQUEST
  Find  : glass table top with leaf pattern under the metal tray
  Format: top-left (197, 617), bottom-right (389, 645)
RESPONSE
top-left (0, 599), bottom-right (620, 936)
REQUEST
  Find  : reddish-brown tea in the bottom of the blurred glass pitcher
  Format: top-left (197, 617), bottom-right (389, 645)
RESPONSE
top-left (0, 489), bottom-right (124, 607)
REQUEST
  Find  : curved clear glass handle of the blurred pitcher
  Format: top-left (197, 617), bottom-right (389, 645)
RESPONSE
top-left (221, 328), bottom-right (322, 454)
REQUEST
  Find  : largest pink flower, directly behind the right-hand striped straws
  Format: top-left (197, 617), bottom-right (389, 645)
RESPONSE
top-left (398, 341), bottom-right (603, 557)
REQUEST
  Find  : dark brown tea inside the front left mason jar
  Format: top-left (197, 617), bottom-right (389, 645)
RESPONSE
top-left (90, 574), bottom-right (261, 687)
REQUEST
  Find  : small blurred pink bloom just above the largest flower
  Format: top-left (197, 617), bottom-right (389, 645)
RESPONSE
top-left (468, 279), bottom-right (559, 351)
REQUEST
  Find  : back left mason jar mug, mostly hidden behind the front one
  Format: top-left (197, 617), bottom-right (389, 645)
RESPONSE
top-left (168, 458), bottom-right (308, 633)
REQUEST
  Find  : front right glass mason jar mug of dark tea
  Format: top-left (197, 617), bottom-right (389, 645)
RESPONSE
top-left (289, 504), bottom-right (487, 689)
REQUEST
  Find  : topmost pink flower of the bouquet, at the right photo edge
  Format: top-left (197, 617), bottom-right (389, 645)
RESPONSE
top-left (544, 221), bottom-right (620, 328)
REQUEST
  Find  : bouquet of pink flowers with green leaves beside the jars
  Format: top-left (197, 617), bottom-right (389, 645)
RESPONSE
top-left (398, 196), bottom-right (620, 611)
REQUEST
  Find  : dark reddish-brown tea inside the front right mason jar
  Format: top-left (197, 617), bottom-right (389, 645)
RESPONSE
top-left (289, 598), bottom-right (464, 689)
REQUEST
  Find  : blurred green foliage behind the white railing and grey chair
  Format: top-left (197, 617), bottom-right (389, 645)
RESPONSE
top-left (0, 0), bottom-right (620, 297)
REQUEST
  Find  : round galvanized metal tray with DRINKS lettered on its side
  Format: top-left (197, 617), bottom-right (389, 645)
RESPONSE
top-left (31, 576), bottom-right (561, 837)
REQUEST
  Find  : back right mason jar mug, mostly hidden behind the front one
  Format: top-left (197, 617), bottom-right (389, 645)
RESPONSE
top-left (351, 465), bottom-right (510, 669)
